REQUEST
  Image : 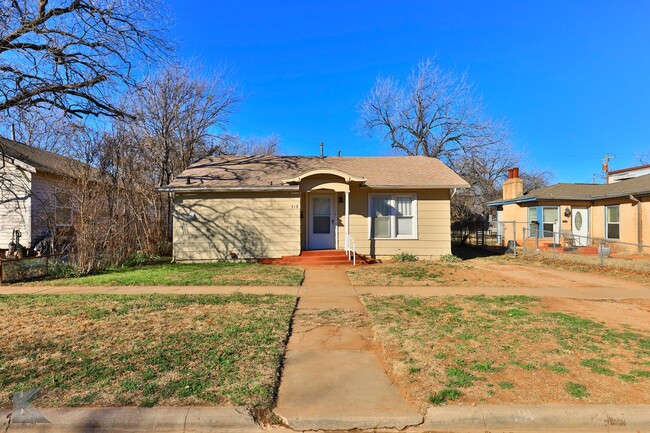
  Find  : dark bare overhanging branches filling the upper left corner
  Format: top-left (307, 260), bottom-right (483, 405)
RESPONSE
top-left (0, 0), bottom-right (169, 117)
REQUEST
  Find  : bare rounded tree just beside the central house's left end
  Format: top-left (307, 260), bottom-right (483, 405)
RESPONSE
top-left (117, 65), bottom-right (239, 246)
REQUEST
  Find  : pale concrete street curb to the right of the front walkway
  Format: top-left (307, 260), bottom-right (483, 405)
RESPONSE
top-left (414, 405), bottom-right (650, 433)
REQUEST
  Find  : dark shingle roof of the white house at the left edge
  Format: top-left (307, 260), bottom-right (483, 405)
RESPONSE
top-left (0, 137), bottom-right (85, 177)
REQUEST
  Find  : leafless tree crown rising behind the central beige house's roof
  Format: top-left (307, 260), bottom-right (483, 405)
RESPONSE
top-left (360, 59), bottom-right (507, 164)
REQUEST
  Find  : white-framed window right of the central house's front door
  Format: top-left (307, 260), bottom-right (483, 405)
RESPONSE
top-left (368, 194), bottom-right (417, 239)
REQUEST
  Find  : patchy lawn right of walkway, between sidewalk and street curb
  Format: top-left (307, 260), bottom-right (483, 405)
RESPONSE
top-left (362, 295), bottom-right (650, 408)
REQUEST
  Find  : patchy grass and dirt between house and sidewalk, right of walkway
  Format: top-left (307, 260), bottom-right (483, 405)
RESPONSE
top-left (348, 256), bottom-right (650, 298)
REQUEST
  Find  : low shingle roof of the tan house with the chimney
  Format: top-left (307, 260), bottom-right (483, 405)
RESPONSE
top-left (489, 174), bottom-right (650, 206)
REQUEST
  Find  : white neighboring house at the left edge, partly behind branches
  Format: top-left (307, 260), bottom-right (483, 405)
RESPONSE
top-left (0, 137), bottom-right (83, 250)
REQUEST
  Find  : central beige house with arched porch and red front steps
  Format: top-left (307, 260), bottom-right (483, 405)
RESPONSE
top-left (162, 156), bottom-right (469, 261)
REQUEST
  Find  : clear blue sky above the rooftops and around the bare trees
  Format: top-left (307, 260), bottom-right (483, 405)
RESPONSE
top-left (168, 0), bottom-right (650, 182)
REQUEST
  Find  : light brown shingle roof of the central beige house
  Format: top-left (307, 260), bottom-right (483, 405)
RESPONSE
top-left (164, 156), bottom-right (469, 190)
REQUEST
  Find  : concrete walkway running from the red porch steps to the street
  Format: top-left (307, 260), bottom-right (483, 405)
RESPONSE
top-left (275, 267), bottom-right (423, 430)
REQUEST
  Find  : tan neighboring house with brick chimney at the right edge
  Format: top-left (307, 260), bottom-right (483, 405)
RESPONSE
top-left (488, 166), bottom-right (650, 253)
